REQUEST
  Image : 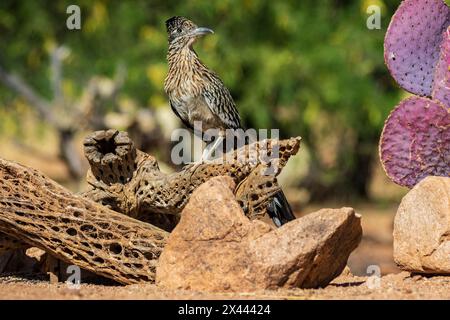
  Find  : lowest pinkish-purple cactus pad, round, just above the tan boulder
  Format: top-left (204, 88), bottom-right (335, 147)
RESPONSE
top-left (380, 97), bottom-right (450, 188)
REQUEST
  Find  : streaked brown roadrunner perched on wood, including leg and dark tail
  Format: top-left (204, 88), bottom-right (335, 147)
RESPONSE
top-left (164, 17), bottom-right (295, 226)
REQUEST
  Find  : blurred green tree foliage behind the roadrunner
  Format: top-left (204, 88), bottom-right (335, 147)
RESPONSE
top-left (0, 0), bottom-right (400, 199)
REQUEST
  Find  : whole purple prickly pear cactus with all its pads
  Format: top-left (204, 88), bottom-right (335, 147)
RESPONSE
top-left (379, 0), bottom-right (450, 188)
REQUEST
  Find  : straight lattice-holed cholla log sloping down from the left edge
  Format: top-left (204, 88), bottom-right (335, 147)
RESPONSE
top-left (0, 160), bottom-right (168, 283)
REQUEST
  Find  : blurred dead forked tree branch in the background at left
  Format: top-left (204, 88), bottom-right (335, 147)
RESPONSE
top-left (0, 46), bottom-right (126, 179)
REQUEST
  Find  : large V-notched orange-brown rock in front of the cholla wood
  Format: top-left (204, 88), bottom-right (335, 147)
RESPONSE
top-left (156, 177), bottom-right (362, 291)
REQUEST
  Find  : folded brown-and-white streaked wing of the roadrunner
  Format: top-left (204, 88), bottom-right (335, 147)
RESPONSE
top-left (202, 77), bottom-right (241, 129)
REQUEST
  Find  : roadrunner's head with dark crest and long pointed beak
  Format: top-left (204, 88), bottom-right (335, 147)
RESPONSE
top-left (166, 17), bottom-right (214, 49)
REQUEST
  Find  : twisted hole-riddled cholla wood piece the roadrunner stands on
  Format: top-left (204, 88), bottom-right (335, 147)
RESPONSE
top-left (83, 130), bottom-right (300, 230)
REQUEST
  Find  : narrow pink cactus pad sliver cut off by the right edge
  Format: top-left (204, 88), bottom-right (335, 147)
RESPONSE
top-left (432, 27), bottom-right (450, 107)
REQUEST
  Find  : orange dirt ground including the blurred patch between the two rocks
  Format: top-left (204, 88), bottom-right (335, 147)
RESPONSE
top-left (0, 204), bottom-right (450, 300)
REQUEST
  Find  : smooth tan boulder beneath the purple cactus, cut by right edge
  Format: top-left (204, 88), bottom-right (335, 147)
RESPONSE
top-left (394, 176), bottom-right (450, 274)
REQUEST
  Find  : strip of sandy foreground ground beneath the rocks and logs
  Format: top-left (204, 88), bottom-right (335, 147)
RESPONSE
top-left (0, 272), bottom-right (450, 300)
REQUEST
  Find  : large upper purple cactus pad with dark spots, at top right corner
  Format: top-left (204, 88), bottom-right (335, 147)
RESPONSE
top-left (384, 0), bottom-right (450, 96)
